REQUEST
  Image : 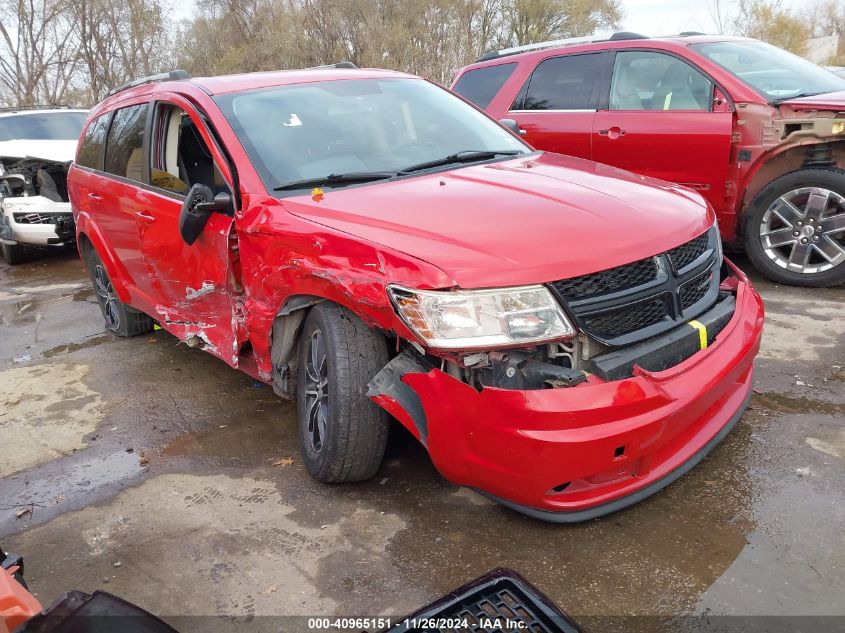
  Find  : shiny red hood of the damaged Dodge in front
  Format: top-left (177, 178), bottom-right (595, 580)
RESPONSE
top-left (283, 153), bottom-right (714, 288)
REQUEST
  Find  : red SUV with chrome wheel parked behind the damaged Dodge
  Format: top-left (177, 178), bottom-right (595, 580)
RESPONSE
top-left (453, 33), bottom-right (845, 286)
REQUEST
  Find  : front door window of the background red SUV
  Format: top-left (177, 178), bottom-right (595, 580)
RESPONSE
top-left (610, 51), bottom-right (713, 110)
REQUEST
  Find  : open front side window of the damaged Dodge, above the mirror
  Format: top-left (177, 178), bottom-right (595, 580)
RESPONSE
top-left (150, 103), bottom-right (227, 195)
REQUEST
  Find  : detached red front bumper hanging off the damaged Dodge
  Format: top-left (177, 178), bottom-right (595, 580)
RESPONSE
top-left (373, 260), bottom-right (763, 522)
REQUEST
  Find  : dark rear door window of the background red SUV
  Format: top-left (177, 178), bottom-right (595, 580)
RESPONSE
top-left (521, 53), bottom-right (602, 110)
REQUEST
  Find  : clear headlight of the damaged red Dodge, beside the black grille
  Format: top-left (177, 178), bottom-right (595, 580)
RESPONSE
top-left (388, 286), bottom-right (575, 350)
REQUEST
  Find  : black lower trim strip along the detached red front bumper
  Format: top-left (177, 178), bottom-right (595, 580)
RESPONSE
top-left (476, 389), bottom-right (752, 523)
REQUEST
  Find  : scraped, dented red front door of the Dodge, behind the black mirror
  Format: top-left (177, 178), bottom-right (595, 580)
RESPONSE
top-left (132, 94), bottom-right (246, 367)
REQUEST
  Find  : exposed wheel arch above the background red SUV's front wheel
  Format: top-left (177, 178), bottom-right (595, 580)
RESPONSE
top-left (737, 141), bottom-right (845, 235)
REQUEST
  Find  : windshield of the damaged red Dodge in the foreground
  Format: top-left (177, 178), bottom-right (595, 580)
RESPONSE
top-left (216, 79), bottom-right (531, 190)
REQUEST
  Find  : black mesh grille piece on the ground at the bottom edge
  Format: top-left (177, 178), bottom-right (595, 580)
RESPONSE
top-left (383, 568), bottom-right (581, 633)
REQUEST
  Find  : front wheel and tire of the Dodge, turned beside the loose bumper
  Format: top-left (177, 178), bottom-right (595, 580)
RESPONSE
top-left (296, 301), bottom-right (389, 483)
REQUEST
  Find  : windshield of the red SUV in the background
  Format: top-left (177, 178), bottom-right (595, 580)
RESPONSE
top-left (691, 41), bottom-right (845, 101)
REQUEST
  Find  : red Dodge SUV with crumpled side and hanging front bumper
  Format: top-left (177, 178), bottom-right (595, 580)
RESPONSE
top-left (68, 65), bottom-right (763, 522)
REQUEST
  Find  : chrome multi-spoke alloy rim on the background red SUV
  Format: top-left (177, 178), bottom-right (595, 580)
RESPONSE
top-left (760, 187), bottom-right (845, 274)
